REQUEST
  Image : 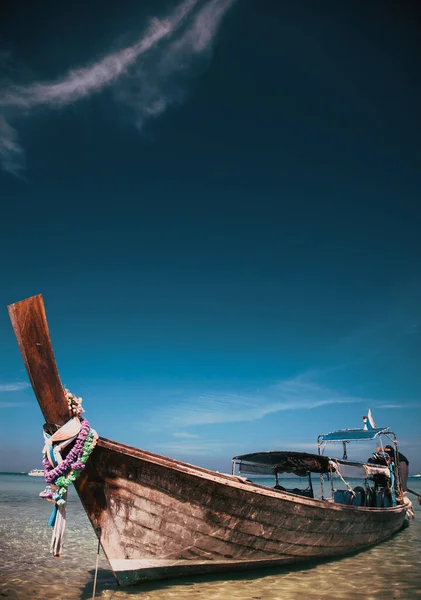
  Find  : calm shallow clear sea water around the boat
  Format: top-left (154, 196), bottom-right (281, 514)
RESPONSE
top-left (0, 475), bottom-right (421, 600)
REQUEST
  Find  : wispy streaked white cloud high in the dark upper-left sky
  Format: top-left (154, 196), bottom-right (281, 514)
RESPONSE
top-left (0, 0), bottom-right (235, 174)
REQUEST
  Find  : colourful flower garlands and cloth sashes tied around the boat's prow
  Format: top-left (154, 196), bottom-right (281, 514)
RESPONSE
top-left (40, 390), bottom-right (98, 556)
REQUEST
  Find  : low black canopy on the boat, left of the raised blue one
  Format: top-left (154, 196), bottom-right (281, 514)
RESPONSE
top-left (232, 450), bottom-right (390, 478)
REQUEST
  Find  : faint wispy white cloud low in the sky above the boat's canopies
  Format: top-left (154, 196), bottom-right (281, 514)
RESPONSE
top-left (143, 376), bottom-right (371, 430)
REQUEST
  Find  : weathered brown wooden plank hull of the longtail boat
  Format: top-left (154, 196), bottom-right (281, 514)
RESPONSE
top-left (77, 439), bottom-right (406, 584)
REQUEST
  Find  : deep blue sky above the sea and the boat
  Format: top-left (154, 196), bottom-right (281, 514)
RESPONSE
top-left (0, 0), bottom-right (421, 473)
